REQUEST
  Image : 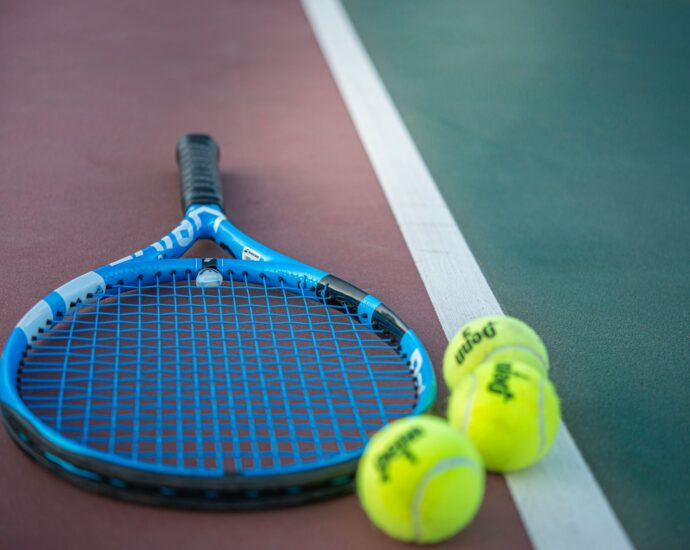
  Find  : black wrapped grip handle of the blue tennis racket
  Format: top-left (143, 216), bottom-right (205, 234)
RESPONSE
top-left (176, 134), bottom-right (223, 212)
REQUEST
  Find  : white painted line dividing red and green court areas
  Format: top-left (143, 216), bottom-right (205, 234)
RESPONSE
top-left (302, 0), bottom-right (632, 550)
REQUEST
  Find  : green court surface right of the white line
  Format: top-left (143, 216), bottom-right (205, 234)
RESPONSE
top-left (345, 0), bottom-right (690, 548)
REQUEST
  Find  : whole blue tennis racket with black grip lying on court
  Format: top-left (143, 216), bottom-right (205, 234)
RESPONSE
top-left (0, 134), bottom-right (436, 509)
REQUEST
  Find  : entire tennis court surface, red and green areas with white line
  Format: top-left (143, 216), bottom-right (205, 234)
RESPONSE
top-left (0, 0), bottom-right (690, 549)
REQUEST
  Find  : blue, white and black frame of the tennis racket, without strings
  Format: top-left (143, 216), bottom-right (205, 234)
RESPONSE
top-left (0, 204), bottom-right (436, 508)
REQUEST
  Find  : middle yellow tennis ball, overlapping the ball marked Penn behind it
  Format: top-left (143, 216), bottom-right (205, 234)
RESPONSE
top-left (448, 361), bottom-right (561, 472)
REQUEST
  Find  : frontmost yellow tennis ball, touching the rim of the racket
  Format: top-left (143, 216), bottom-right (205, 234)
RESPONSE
top-left (357, 415), bottom-right (484, 543)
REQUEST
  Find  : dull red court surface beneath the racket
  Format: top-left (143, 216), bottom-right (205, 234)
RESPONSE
top-left (0, 0), bottom-right (529, 549)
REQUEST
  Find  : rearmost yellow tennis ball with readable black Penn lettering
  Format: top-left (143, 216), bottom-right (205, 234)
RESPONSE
top-left (443, 316), bottom-right (549, 390)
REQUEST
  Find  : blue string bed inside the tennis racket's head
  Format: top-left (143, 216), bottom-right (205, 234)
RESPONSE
top-left (18, 274), bottom-right (416, 473)
